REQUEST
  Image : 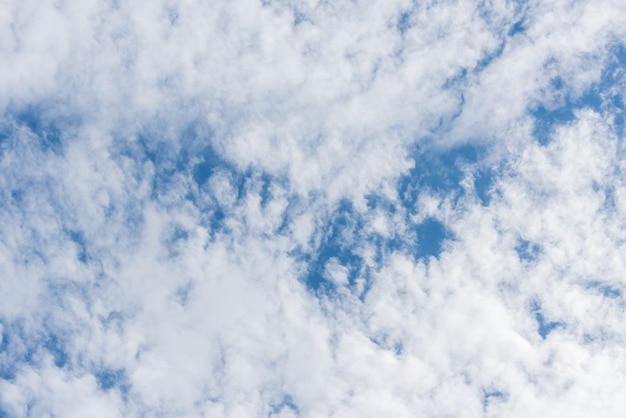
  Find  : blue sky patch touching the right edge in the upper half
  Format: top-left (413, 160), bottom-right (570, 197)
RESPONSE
top-left (529, 45), bottom-right (626, 145)
